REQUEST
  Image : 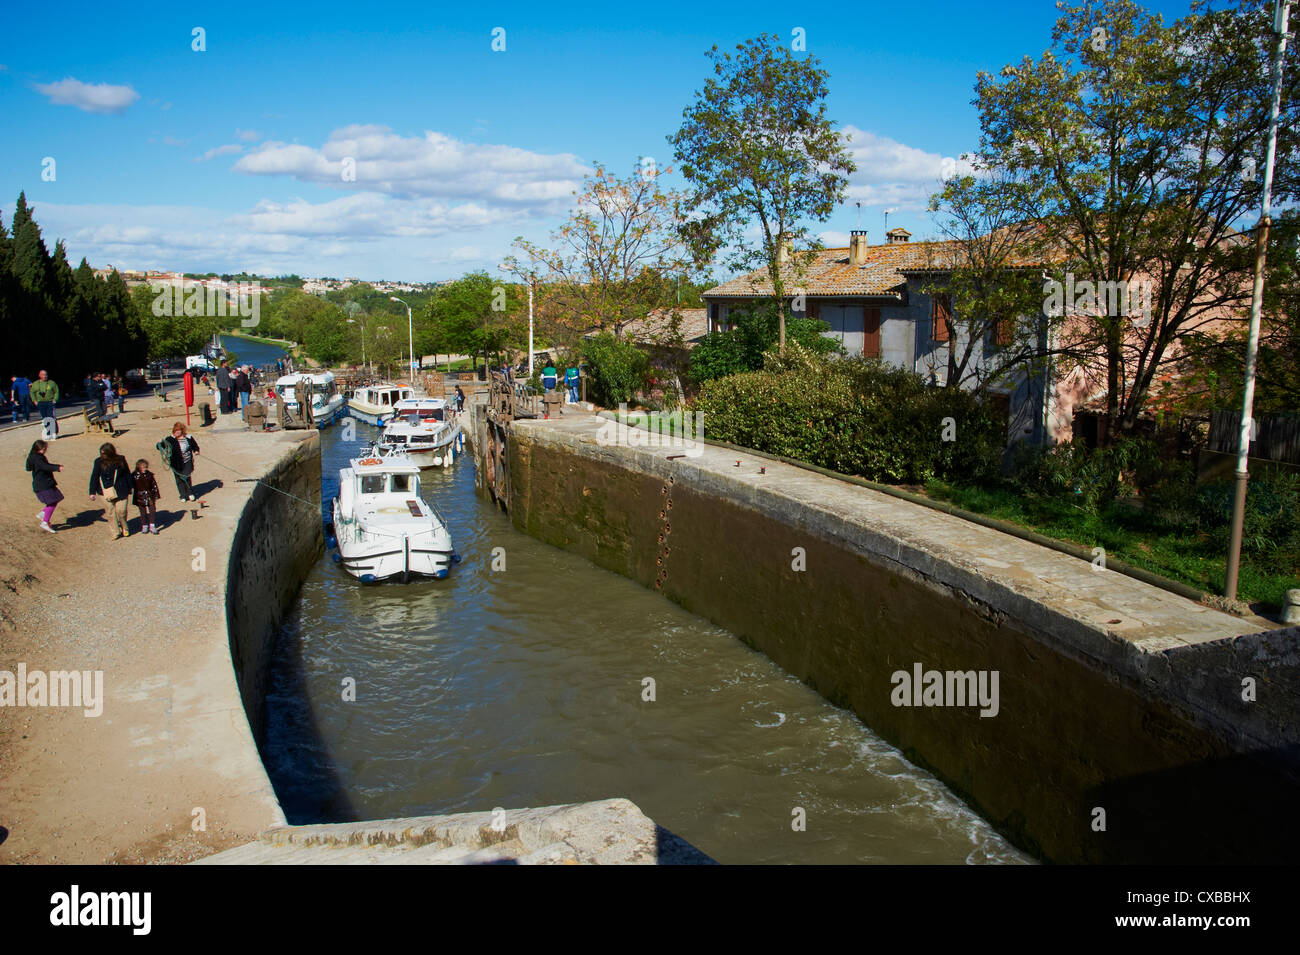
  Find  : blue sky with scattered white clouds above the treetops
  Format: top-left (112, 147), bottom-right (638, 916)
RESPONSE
top-left (0, 0), bottom-right (1186, 281)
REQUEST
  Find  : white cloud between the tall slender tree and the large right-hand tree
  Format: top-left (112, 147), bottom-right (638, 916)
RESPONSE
top-left (844, 126), bottom-right (971, 212)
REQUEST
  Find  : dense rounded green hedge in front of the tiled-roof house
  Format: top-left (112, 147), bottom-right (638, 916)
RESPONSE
top-left (696, 356), bottom-right (1004, 483)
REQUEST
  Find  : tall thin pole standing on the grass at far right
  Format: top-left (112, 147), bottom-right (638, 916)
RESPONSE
top-left (1223, 0), bottom-right (1291, 600)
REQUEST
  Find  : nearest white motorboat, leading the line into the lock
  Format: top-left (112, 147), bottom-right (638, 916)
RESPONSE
top-left (326, 451), bottom-right (459, 583)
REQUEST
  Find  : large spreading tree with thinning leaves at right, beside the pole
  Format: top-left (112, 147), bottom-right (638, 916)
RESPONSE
top-left (976, 0), bottom-right (1300, 435)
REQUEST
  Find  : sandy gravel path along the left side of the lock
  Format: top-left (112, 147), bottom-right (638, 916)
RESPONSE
top-left (0, 396), bottom-right (309, 863)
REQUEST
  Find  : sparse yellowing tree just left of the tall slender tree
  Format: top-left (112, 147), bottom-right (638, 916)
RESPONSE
top-left (506, 164), bottom-right (692, 337)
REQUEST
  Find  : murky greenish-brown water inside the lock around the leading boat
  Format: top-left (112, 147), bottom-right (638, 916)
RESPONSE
top-left (263, 424), bottom-right (1028, 864)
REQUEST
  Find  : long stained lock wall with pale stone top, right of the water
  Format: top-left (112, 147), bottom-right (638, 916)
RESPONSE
top-left (496, 418), bottom-right (1300, 863)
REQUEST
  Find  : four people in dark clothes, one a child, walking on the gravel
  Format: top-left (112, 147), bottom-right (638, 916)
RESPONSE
top-left (27, 421), bottom-right (199, 541)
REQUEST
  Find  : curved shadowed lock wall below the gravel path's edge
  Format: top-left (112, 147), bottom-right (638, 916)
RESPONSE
top-left (226, 433), bottom-right (325, 742)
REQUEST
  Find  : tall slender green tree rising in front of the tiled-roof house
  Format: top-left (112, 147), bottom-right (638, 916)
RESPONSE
top-left (668, 35), bottom-right (855, 352)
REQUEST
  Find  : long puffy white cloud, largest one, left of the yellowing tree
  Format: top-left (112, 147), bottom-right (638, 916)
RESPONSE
top-left (234, 126), bottom-right (588, 212)
